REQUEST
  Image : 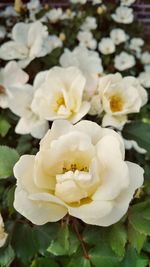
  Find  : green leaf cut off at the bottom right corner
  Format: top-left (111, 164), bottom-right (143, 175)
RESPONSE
top-left (120, 247), bottom-right (148, 267)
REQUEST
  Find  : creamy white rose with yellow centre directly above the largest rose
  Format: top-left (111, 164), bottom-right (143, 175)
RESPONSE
top-left (31, 67), bottom-right (90, 123)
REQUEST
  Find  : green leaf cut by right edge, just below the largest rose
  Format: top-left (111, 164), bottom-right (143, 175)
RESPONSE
top-left (129, 201), bottom-right (150, 235)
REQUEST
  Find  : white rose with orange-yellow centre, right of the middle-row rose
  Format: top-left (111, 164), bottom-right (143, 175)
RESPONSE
top-left (99, 73), bottom-right (148, 129)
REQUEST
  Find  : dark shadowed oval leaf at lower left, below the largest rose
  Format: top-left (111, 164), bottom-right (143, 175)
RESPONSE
top-left (12, 223), bottom-right (37, 266)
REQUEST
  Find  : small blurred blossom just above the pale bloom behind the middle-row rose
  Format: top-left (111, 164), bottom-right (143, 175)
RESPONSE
top-left (77, 31), bottom-right (97, 50)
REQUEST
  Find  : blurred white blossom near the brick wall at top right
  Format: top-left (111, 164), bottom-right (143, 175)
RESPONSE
top-left (111, 6), bottom-right (134, 24)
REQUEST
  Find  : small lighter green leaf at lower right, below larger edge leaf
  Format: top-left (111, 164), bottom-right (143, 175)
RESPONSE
top-left (128, 225), bottom-right (146, 253)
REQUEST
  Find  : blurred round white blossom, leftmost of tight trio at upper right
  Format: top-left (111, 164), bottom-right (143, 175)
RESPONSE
top-left (98, 37), bottom-right (116, 55)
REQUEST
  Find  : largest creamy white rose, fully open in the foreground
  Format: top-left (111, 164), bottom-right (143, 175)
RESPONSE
top-left (14, 120), bottom-right (143, 226)
